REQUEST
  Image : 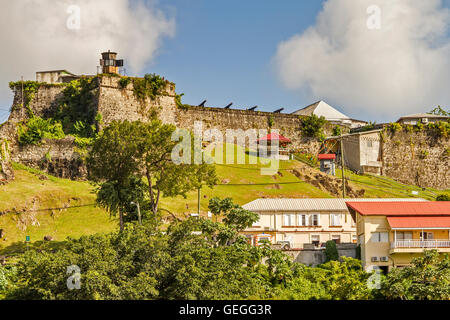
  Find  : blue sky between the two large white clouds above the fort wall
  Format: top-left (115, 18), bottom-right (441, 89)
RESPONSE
top-left (139, 0), bottom-right (322, 111)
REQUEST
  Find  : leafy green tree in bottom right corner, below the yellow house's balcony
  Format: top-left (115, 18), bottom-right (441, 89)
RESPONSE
top-left (381, 250), bottom-right (450, 300)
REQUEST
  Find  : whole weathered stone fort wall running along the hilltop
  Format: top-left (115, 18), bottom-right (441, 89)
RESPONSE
top-left (0, 77), bottom-right (450, 189)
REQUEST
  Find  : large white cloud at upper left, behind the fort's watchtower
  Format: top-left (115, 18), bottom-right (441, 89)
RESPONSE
top-left (0, 0), bottom-right (175, 106)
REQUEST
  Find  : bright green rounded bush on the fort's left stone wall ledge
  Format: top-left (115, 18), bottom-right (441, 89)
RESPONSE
top-left (17, 117), bottom-right (65, 145)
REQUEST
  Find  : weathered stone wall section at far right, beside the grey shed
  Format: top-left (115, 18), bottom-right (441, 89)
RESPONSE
top-left (382, 130), bottom-right (450, 189)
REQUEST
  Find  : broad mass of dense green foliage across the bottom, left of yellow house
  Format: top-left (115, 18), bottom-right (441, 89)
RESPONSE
top-left (3, 201), bottom-right (370, 299)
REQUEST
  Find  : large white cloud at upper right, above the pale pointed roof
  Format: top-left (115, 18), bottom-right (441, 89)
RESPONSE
top-left (275, 0), bottom-right (450, 120)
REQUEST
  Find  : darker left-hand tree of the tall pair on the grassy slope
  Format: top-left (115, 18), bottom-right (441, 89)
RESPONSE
top-left (87, 121), bottom-right (141, 230)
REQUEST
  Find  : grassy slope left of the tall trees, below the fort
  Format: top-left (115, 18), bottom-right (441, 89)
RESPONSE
top-left (0, 164), bottom-right (117, 254)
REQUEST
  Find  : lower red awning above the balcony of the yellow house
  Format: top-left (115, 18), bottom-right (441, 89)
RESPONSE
top-left (387, 216), bottom-right (450, 229)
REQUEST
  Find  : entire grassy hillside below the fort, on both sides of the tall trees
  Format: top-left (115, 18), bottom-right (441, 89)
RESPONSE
top-left (0, 144), bottom-right (450, 254)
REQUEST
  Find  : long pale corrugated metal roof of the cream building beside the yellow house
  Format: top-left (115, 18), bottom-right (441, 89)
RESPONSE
top-left (242, 198), bottom-right (426, 212)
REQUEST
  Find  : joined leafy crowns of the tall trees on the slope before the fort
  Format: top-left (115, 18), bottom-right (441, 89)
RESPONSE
top-left (87, 120), bottom-right (217, 229)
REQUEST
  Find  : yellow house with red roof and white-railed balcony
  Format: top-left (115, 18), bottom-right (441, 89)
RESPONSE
top-left (346, 200), bottom-right (450, 271)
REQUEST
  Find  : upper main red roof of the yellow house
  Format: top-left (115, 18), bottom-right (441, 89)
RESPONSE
top-left (346, 201), bottom-right (450, 216)
